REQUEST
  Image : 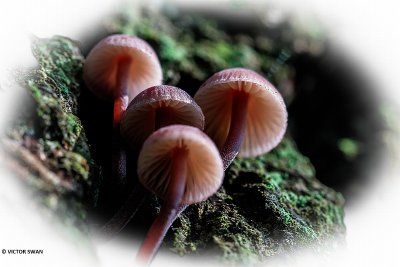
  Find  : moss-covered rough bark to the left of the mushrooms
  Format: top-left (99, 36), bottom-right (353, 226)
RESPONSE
top-left (8, 36), bottom-right (99, 234)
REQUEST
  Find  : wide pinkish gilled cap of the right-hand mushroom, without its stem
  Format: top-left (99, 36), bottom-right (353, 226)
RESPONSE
top-left (194, 68), bottom-right (287, 157)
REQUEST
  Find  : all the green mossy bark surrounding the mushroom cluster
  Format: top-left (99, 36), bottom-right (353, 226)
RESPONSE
top-left (2, 7), bottom-right (345, 263)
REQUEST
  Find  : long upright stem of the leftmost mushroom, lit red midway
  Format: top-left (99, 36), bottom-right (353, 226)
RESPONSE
top-left (112, 58), bottom-right (131, 188)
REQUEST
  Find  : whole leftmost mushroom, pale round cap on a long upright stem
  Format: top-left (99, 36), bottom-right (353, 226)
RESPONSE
top-left (83, 34), bottom-right (162, 188)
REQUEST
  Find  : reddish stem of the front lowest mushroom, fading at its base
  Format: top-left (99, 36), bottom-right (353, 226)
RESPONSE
top-left (136, 148), bottom-right (187, 266)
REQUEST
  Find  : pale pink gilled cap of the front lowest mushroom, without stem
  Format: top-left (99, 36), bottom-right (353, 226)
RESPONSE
top-left (138, 125), bottom-right (224, 204)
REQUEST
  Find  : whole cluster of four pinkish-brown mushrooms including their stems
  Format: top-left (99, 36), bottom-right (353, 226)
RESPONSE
top-left (84, 35), bottom-right (287, 265)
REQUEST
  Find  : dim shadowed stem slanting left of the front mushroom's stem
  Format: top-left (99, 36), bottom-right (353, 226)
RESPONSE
top-left (100, 183), bottom-right (148, 240)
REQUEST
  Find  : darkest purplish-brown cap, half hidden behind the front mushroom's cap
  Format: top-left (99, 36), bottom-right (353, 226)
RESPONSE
top-left (121, 85), bottom-right (204, 147)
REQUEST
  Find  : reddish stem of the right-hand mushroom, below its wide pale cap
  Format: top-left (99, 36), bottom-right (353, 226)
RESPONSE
top-left (221, 92), bottom-right (249, 170)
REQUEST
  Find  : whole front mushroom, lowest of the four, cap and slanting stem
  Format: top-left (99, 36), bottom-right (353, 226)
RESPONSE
top-left (137, 125), bottom-right (224, 265)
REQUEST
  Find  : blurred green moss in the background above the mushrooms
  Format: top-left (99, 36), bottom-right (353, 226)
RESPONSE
top-left (107, 14), bottom-right (290, 88)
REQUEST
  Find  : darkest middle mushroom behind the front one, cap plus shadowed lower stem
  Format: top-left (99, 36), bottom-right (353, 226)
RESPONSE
top-left (101, 85), bottom-right (204, 239)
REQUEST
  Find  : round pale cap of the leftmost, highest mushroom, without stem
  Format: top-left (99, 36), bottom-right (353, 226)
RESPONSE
top-left (83, 34), bottom-right (162, 100)
